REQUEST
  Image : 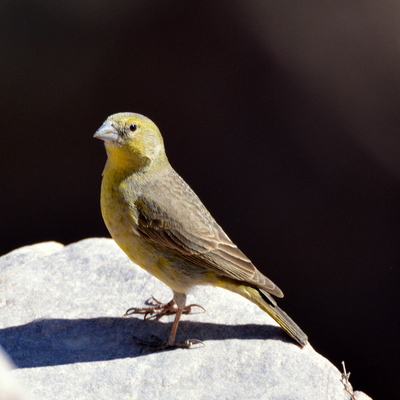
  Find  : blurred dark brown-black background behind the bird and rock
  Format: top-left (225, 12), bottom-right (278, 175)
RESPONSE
top-left (0, 0), bottom-right (400, 400)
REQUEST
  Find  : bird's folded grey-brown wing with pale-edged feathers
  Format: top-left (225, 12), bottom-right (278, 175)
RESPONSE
top-left (136, 181), bottom-right (283, 297)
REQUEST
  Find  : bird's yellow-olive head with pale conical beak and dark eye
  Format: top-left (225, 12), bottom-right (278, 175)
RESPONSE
top-left (94, 113), bottom-right (167, 171)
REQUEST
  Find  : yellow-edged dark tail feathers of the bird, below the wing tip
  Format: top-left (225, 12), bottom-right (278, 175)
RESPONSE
top-left (219, 284), bottom-right (308, 347)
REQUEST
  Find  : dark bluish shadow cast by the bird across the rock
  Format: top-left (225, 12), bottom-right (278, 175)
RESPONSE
top-left (0, 317), bottom-right (290, 368)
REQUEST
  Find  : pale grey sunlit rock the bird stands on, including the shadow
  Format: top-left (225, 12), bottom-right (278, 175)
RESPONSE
top-left (0, 239), bottom-right (368, 400)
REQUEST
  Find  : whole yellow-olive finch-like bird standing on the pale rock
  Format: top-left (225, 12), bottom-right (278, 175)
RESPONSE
top-left (94, 112), bottom-right (308, 350)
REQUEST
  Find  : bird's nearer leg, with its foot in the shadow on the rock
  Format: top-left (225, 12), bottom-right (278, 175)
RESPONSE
top-left (132, 292), bottom-right (203, 351)
